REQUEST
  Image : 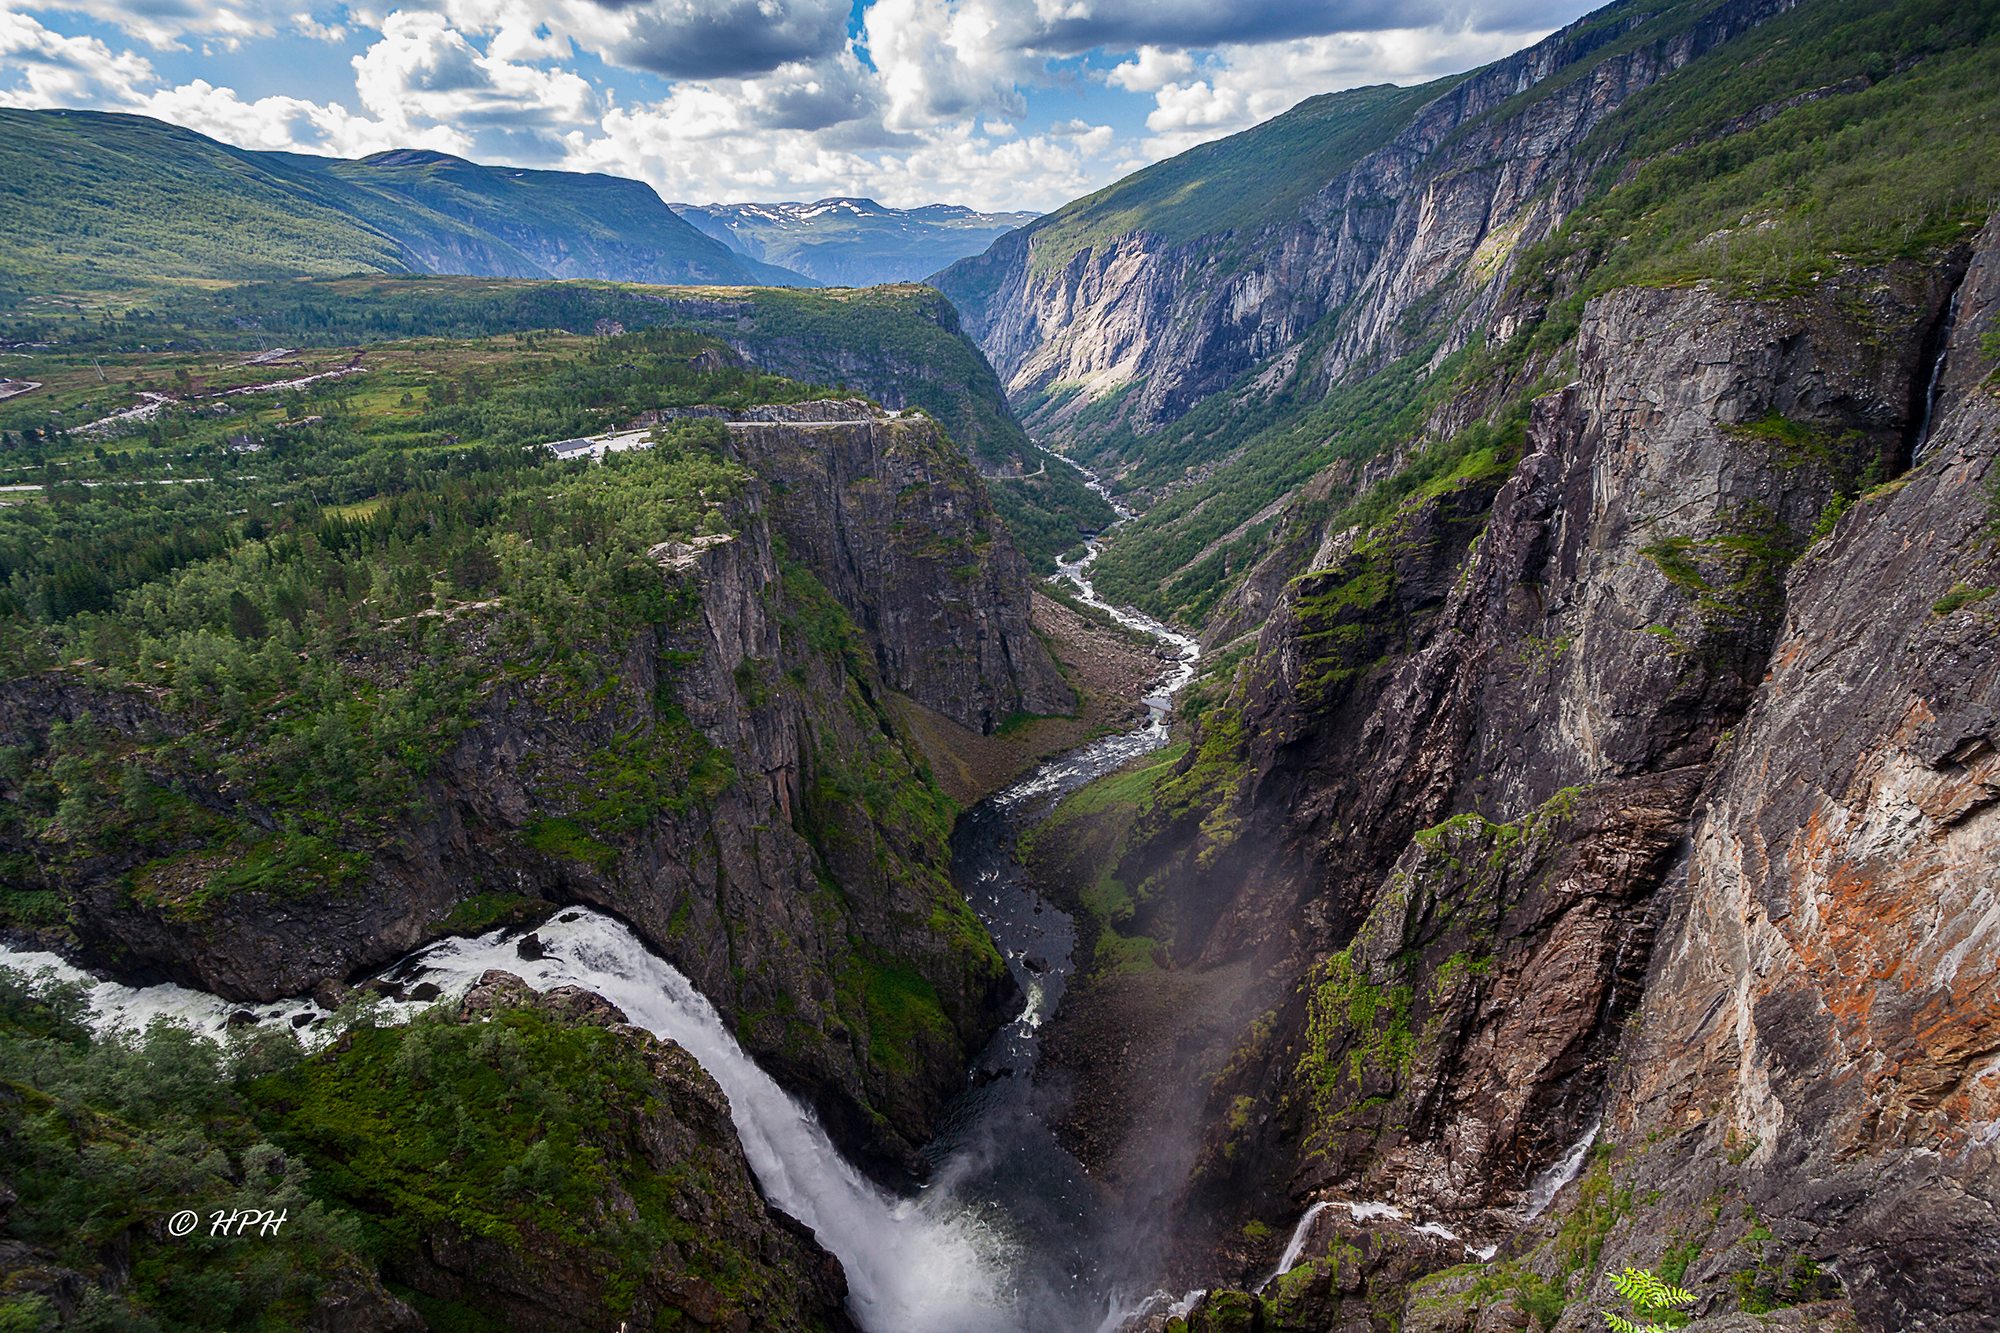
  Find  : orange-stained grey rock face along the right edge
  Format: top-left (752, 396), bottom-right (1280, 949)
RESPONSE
top-left (1612, 230), bottom-right (2000, 1329)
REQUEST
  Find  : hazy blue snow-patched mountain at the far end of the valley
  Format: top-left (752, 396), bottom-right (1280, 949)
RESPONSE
top-left (672, 198), bottom-right (1040, 286)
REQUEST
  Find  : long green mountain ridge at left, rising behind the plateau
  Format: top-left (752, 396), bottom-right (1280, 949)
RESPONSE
top-left (0, 110), bottom-right (812, 294)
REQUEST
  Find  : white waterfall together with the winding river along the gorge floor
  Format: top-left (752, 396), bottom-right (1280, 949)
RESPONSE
top-left (0, 454), bottom-right (1200, 1333)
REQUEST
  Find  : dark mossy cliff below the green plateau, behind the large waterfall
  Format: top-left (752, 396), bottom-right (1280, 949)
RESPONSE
top-left (0, 404), bottom-right (1072, 1171)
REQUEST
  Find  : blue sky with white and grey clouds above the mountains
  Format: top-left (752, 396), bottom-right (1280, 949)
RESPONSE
top-left (0, 0), bottom-right (1594, 210)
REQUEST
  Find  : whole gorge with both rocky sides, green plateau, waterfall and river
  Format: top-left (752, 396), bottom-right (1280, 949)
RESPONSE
top-left (0, 0), bottom-right (2000, 1333)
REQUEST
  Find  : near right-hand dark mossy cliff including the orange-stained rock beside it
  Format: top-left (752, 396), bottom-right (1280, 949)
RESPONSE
top-left (1118, 205), bottom-right (2000, 1331)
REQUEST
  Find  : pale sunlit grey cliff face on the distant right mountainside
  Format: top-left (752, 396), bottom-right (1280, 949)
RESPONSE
top-left (938, 0), bottom-right (1796, 442)
